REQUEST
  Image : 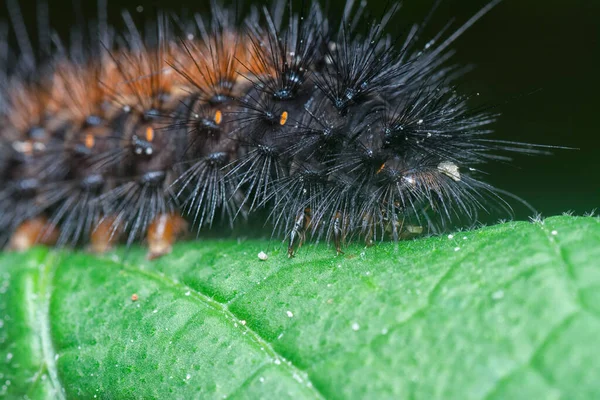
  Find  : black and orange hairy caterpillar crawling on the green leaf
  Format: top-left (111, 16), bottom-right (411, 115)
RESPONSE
top-left (0, 0), bottom-right (544, 259)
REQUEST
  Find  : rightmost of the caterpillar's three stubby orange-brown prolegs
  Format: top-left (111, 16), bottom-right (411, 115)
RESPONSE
top-left (147, 214), bottom-right (187, 260)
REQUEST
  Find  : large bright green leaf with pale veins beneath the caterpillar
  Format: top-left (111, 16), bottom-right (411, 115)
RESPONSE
top-left (0, 216), bottom-right (600, 399)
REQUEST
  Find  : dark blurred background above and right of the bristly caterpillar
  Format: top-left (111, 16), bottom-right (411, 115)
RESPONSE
top-left (0, 0), bottom-right (600, 219)
